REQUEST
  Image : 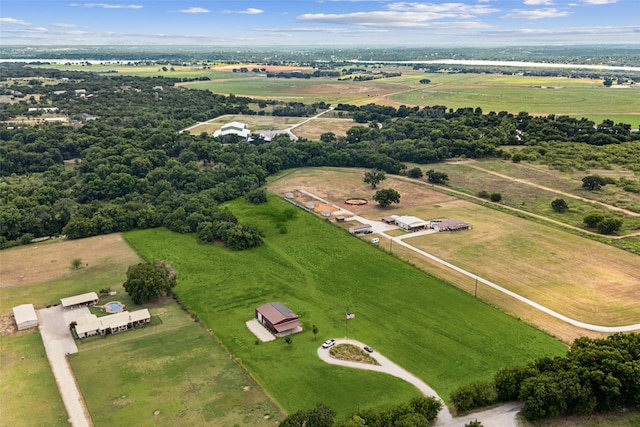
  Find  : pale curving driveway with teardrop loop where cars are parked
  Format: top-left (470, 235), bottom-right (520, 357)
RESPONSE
top-left (318, 338), bottom-right (522, 427)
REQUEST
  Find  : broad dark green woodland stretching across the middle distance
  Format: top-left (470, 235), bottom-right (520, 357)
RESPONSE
top-left (0, 63), bottom-right (640, 248)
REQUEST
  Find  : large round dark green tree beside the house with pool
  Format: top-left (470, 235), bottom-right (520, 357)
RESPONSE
top-left (123, 261), bottom-right (177, 304)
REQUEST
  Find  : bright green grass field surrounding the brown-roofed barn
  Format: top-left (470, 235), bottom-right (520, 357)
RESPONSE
top-left (125, 196), bottom-right (566, 415)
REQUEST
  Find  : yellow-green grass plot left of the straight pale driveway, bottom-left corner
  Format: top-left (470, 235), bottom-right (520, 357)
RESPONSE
top-left (0, 329), bottom-right (69, 427)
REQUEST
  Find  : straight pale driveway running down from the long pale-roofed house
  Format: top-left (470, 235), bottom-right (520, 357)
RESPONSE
top-left (38, 306), bottom-right (93, 427)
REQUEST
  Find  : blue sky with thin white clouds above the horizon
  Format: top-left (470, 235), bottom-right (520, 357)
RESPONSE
top-left (0, 0), bottom-right (640, 47)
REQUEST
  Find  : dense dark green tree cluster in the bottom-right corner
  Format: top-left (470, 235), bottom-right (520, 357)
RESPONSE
top-left (452, 333), bottom-right (640, 420)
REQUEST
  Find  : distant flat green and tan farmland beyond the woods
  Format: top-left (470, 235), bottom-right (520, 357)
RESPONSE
top-left (35, 64), bottom-right (640, 128)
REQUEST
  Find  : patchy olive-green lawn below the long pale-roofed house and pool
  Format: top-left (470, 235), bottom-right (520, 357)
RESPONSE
top-left (70, 301), bottom-right (284, 426)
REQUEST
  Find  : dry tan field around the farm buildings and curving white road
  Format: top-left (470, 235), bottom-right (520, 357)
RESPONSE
top-left (269, 168), bottom-right (640, 340)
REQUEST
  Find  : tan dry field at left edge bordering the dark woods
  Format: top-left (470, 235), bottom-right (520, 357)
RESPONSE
top-left (0, 234), bottom-right (140, 288)
